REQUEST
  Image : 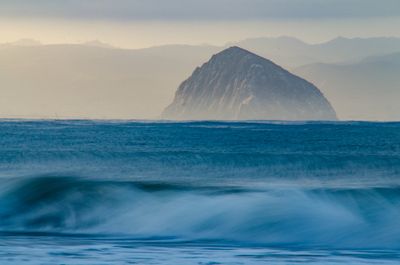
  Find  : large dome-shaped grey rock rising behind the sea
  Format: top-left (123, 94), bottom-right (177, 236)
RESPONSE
top-left (162, 47), bottom-right (336, 120)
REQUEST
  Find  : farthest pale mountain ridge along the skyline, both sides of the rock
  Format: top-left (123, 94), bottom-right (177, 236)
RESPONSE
top-left (0, 36), bottom-right (400, 69)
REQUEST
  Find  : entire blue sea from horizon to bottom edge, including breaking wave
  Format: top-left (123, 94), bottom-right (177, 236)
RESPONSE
top-left (0, 120), bottom-right (400, 264)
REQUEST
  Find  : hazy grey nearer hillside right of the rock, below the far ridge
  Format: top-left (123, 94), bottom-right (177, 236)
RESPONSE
top-left (295, 53), bottom-right (400, 120)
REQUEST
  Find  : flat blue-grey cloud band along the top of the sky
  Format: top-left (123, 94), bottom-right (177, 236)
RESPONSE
top-left (0, 0), bottom-right (400, 20)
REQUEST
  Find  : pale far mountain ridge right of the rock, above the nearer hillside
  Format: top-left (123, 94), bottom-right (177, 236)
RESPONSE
top-left (234, 37), bottom-right (400, 68)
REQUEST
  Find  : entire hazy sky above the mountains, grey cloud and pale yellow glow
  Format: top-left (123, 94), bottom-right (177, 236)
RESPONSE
top-left (0, 0), bottom-right (400, 48)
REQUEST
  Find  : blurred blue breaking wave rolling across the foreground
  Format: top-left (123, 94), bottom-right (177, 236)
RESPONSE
top-left (0, 176), bottom-right (400, 249)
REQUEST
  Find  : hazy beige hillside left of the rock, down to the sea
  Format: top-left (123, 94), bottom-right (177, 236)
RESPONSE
top-left (0, 45), bottom-right (218, 118)
